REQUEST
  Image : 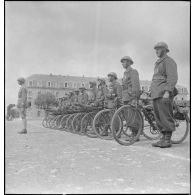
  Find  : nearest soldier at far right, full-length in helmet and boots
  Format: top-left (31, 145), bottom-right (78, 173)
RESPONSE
top-left (151, 42), bottom-right (178, 148)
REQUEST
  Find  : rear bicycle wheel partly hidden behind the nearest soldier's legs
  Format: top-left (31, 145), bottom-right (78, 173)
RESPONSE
top-left (171, 113), bottom-right (190, 144)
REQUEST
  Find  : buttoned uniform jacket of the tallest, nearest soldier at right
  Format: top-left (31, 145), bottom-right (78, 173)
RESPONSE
top-left (151, 55), bottom-right (178, 99)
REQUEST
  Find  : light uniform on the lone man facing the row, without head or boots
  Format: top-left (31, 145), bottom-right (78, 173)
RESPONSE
top-left (17, 86), bottom-right (27, 119)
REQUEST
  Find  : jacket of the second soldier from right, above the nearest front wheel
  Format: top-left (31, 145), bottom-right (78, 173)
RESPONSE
top-left (122, 66), bottom-right (140, 101)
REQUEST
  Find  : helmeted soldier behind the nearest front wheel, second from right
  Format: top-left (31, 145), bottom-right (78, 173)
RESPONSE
top-left (121, 56), bottom-right (140, 104)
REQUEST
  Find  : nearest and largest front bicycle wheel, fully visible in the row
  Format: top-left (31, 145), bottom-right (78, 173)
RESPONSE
top-left (111, 105), bottom-right (144, 146)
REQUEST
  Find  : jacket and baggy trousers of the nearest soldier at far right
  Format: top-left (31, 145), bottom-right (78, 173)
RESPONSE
top-left (151, 55), bottom-right (178, 131)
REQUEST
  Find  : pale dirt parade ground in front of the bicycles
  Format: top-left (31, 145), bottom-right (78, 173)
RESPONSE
top-left (5, 120), bottom-right (190, 194)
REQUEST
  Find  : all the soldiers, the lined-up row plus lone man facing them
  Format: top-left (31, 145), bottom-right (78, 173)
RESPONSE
top-left (18, 42), bottom-right (178, 148)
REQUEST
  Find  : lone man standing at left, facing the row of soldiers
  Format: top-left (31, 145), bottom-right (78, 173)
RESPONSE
top-left (17, 77), bottom-right (27, 134)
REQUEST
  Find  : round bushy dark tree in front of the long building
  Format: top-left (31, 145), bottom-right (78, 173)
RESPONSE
top-left (34, 92), bottom-right (57, 109)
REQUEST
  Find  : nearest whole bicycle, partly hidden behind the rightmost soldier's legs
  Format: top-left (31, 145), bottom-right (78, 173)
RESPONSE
top-left (111, 92), bottom-right (189, 146)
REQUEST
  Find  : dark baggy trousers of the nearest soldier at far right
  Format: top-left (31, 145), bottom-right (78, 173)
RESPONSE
top-left (153, 97), bottom-right (175, 132)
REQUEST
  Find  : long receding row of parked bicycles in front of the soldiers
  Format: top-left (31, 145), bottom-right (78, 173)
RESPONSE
top-left (42, 98), bottom-right (190, 145)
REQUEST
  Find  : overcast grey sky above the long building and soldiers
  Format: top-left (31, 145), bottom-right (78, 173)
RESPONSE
top-left (5, 1), bottom-right (190, 104)
